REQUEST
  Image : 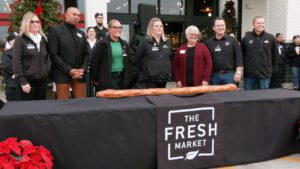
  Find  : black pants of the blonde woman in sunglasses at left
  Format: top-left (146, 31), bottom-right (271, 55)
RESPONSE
top-left (19, 79), bottom-right (47, 100)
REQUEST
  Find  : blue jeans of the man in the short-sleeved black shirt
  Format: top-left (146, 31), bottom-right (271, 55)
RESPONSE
top-left (210, 71), bottom-right (235, 85)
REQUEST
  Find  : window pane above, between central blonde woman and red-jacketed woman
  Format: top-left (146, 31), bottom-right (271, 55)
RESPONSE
top-left (160, 0), bottom-right (185, 15)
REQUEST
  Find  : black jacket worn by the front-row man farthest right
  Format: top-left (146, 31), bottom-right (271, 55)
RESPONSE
top-left (241, 31), bottom-right (279, 78)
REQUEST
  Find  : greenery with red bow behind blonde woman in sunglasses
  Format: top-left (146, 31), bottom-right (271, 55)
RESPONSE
top-left (9, 0), bottom-right (61, 33)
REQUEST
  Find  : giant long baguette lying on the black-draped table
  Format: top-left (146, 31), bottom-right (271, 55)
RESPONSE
top-left (96, 84), bottom-right (237, 98)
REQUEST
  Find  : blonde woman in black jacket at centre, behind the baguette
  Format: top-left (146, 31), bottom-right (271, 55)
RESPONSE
top-left (136, 17), bottom-right (172, 88)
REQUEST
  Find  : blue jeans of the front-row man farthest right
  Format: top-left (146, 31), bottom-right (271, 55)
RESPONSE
top-left (244, 78), bottom-right (270, 90)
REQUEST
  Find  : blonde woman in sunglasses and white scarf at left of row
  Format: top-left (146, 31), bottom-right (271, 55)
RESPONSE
top-left (12, 12), bottom-right (50, 100)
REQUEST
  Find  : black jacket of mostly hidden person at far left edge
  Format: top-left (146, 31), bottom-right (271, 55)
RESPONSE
top-left (2, 49), bottom-right (18, 87)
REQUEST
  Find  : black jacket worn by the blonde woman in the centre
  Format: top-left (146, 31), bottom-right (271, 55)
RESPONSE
top-left (136, 38), bottom-right (173, 82)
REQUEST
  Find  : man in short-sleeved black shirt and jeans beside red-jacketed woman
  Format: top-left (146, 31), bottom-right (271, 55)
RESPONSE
top-left (205, 18), bottom-right (243, 85)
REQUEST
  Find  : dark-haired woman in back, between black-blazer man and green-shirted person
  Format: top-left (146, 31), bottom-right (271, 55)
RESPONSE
top-left (86, 26), bottom-right (100, 97)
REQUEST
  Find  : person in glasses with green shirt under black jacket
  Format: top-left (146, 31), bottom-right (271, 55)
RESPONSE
top-left (90, 19), bottom-right (131, 91)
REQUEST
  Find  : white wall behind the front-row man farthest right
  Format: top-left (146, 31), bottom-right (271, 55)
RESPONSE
top-left (242, 0), bottom-right (300, 42)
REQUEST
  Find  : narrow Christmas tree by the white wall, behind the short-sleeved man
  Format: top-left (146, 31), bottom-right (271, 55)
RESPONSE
top-left (222, 0), bottom-right (236, 33)
